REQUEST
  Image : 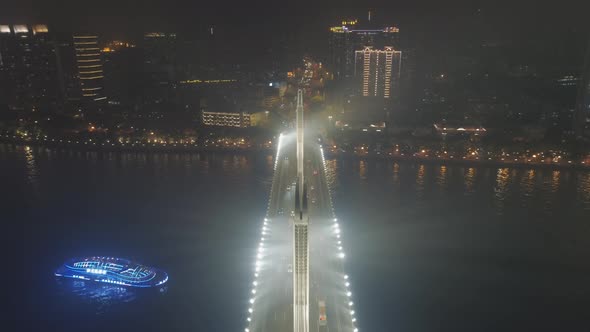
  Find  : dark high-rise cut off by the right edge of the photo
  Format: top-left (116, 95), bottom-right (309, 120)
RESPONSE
top-left (573, 41), bottom-right (590, 138)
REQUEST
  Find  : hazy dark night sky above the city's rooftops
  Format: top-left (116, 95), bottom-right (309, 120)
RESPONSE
top-left (0, 0), bottom-right (590, 70)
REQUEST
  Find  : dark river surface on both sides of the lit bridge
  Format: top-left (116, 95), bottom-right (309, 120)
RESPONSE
top-left (0, 145), bottom-right (590, 332)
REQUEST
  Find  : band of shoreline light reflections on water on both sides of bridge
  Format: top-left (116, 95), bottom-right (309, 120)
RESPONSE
top-left (12, 146), bottom-right (590, 214)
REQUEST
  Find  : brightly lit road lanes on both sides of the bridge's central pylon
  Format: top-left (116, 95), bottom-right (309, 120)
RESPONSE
top-left (248, 135), bottom-right (354, 332)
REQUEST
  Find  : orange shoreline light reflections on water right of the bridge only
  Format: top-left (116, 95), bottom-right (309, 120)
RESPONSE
top-left (326, 159), bottom-right (590, 215)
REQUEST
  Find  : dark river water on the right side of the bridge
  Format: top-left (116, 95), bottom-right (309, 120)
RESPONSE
top-left (334, 159), bottom-right (590, 331)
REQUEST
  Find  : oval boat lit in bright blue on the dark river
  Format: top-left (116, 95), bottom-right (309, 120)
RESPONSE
top-left (54, 256), bottom-right (168, 288)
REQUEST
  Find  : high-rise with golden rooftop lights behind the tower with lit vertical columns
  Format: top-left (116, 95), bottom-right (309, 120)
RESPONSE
top-left (328, 19), bottom-right (400, 78)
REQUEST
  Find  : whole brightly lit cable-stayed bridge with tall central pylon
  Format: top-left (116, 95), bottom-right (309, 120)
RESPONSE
top-left (245, 90), bottom-right (358, 332)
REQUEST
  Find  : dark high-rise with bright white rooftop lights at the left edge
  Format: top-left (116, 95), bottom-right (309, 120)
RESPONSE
top-left (0, 24), bottom-right (59, 109)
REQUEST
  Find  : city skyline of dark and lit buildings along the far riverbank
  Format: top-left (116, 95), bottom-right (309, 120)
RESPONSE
top-left (0, 2), bottom-right (586, 160)
